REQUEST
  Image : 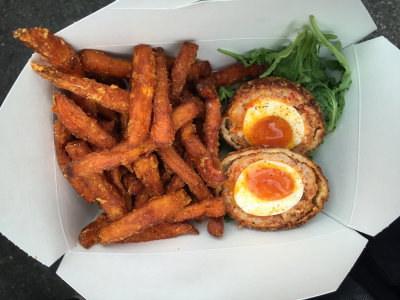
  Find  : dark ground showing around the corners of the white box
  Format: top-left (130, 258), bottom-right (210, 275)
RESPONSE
top-left (0, 0), bottom-right (400, 300)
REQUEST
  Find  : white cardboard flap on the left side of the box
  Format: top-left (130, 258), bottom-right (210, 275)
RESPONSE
top-left (0, 65), bottom-right (67, 266)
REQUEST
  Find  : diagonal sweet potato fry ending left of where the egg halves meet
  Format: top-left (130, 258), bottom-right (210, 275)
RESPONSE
top-left (181, 123), bottom-right (227, 188)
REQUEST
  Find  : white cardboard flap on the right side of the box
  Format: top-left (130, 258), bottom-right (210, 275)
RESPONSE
top-left (350, 37), bottom-right (400, 235)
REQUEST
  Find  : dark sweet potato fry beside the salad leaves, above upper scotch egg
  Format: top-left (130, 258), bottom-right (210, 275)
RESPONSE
top-left (212, 64), bottom-right (266, 88)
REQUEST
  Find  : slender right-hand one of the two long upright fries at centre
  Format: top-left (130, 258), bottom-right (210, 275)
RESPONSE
top-left (150, 48), bottom-right (175, 147)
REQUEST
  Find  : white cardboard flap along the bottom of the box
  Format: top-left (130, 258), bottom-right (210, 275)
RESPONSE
top-left (57, 214), bottom-right (366, 299)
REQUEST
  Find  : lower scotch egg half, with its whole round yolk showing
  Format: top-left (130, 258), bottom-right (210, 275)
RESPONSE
top-left (221, 147), bottom-right (329, 230)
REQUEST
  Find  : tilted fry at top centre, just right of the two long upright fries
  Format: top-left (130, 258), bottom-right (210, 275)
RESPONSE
top-left (171, 42), bottom-right (199, 106)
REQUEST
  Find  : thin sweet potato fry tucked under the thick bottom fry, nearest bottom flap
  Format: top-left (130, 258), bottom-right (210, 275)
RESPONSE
top-left (123, 222), bottom-right (199, 243)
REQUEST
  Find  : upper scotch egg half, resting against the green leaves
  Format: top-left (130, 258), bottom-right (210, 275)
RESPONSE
top-left (221, 77), bottom-right (325, 153)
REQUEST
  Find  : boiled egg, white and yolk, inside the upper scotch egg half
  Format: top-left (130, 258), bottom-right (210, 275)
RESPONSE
top-left (243, 99), bottom-right (304, 149)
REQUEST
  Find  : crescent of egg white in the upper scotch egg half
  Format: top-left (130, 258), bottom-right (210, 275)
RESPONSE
top-left (243, 99), bottom-right (304, 149)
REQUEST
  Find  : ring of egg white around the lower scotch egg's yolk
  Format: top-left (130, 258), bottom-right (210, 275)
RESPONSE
top-left (234, 160), bottom-right (304, 216)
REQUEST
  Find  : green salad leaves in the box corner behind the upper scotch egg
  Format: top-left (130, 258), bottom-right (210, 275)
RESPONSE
top-left (218, 16), bottom-right (351, 133)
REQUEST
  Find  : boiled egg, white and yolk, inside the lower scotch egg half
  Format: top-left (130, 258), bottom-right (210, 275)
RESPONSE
top-left (234, 160), bottom-right (304, 216)
